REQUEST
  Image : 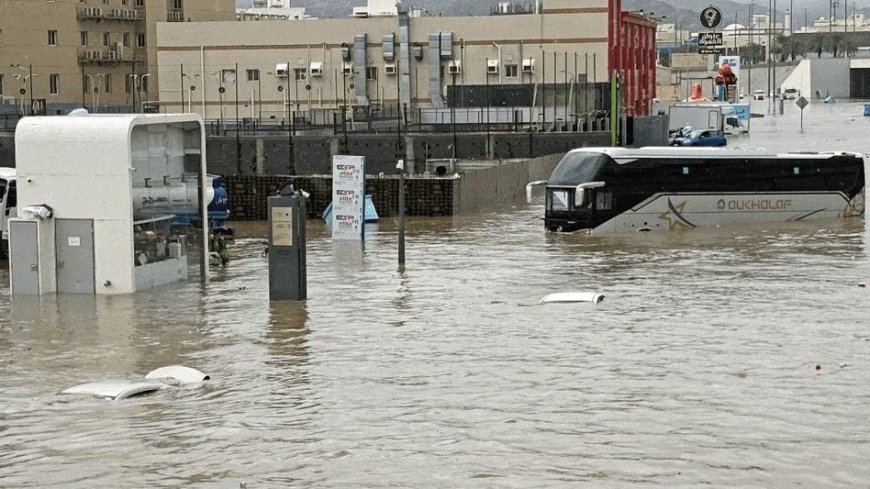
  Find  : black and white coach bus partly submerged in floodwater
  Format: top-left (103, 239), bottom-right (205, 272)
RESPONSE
top-left (527, 147), bottom-right (865, 233)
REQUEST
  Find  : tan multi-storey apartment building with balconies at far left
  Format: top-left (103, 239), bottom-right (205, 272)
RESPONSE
top-left (0, 0), bottom-right (236, 114)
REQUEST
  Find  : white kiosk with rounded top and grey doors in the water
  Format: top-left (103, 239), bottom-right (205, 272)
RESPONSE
top-left (9, 111), bottom-right (211, 295)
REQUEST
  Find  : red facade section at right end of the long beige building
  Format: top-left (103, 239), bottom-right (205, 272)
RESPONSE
top-left (607, 0), bottom-right (656, 115)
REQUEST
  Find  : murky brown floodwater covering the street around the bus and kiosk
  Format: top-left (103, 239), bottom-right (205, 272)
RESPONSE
top-left (0, 101), bottom-right (870, 489)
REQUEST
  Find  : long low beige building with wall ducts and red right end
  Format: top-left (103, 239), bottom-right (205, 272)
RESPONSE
top-left (157, 0), bottom-right (655, 120)
